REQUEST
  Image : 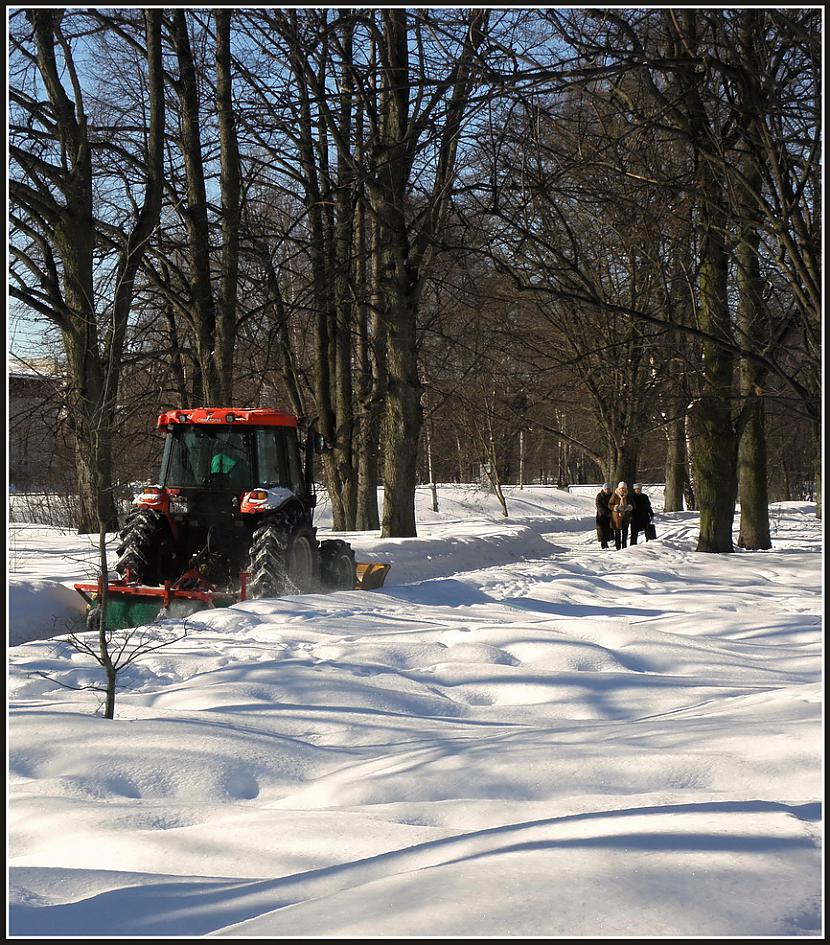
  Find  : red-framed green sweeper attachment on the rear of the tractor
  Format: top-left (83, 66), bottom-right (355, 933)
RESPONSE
top-left (75, 581), bottom-right (239, 630)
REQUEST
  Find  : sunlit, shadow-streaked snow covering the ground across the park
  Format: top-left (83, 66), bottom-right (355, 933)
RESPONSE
top-left (8, 487), bottom-right (823, 938)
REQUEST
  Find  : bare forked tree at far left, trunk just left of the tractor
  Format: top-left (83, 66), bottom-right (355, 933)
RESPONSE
top-left (9, 10), bottom-right (164, 532)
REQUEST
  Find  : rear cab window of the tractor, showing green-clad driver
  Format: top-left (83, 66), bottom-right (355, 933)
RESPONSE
top-left (163, 425), bottom-right (255, 492)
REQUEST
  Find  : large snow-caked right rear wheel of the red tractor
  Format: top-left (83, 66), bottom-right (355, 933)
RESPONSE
top-left (248, 511), bottom-right (317, 598)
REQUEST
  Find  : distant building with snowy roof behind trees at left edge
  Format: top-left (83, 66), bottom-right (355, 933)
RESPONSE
top-left (8, 355), bottom-right (73, 492)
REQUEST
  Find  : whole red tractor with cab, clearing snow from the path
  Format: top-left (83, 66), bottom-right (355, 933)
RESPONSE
top-left (75, 407), bottom-right (389, 630)
